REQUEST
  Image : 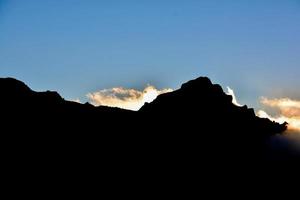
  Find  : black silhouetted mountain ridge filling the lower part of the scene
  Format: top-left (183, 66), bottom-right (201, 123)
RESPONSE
top-left (0, 77), bottom-right (299, 192)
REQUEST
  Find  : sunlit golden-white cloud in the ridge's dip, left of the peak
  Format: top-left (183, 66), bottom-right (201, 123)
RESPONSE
top-left (87, 85), bottom-right (173, 110)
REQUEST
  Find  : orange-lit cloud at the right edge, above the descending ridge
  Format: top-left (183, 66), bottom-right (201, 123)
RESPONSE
top-left (257, 97), bottom-right (300, 131)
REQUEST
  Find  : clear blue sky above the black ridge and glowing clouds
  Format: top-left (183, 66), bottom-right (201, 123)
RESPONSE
top-left (0, 0), bottom-right (300, 107)
